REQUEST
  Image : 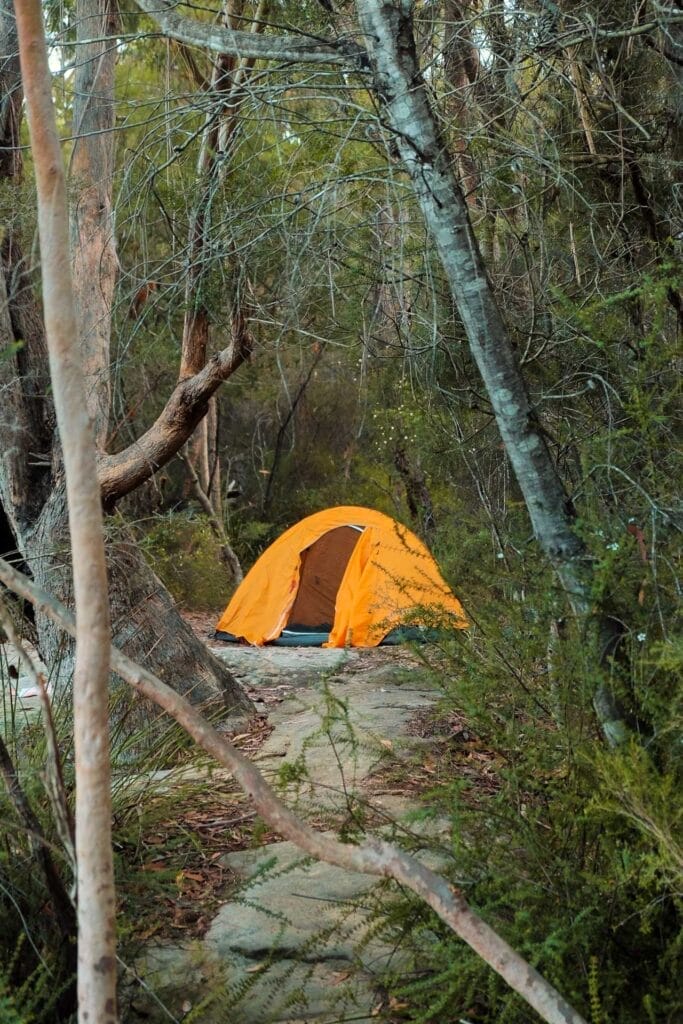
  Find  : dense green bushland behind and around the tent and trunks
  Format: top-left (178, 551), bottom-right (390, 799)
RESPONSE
top-left (0, 0), bottom-right (683, 1024)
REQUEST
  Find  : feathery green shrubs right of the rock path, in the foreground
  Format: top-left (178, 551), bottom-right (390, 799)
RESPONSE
top-left (378, 539), bottom-right (683, 1024)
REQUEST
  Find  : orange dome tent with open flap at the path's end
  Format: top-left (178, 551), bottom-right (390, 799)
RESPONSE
top-left (216, 505), bottom-right (467, 647)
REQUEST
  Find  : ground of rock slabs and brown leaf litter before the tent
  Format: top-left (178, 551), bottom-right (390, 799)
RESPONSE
top-left (0, 614), bottom-right (498, 1024)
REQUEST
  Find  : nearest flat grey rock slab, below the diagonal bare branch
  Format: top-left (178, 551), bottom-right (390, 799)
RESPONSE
top-left (126, 843), bottom-right (403, 1024)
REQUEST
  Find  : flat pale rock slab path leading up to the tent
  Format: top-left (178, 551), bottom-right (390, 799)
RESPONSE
top-left (124, 647), bottom-right (448, 1024)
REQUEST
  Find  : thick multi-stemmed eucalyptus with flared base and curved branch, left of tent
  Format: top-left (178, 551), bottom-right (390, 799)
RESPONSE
top-left (0, 0), bottom-right (252, 739)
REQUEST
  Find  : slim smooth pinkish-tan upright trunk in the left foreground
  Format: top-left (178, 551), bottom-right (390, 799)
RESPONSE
top-left (14, 0), bottom-right (117, 1024)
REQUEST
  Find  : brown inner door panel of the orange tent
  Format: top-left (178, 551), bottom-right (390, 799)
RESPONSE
top-left (287, 526), bottom-right (360, 632)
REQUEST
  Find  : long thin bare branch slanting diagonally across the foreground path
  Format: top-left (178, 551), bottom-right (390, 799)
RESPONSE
top-left (0, 558), bottom-right (586, 1024)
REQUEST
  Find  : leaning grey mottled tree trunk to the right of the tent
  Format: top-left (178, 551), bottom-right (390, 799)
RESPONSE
top-left (356, 0), bottom-right (625, 742)
